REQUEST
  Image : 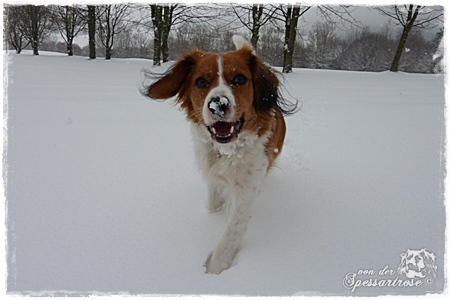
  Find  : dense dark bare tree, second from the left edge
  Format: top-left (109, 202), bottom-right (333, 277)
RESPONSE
top-left (16, 5), bottom-right (52, 55)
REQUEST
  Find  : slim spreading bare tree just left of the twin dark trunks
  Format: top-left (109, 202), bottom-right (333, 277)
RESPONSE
top-left (97, 4), bottom-right (130, 59)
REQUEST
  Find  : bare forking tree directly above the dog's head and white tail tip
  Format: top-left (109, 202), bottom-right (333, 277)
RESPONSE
top-left (231, 4), bottom-right (277, 49)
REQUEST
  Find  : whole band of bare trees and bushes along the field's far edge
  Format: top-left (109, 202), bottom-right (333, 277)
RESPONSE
top-left (5, 4), bottom-right (444, 73)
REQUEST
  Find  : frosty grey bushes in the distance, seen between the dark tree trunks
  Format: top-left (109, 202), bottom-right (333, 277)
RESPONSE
top-left (35, 22), bottom-right (443, 73)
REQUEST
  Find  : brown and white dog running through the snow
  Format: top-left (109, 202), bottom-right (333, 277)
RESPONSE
top-left (146, 36), bottom-right (294, 274)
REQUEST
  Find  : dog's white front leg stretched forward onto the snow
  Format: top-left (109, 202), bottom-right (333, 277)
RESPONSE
top-left (206, 168), bottom-right (264, 274)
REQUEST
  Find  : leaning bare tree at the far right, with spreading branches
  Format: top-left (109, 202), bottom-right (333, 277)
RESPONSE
top-left (377, 4), bottom-right (444, 72)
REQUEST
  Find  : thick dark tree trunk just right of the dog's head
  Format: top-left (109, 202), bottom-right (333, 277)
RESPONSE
top-left (283, 6), bottom-right (300, 73)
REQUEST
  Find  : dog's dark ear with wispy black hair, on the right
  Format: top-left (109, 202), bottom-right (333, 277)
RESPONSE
top-left (250, 53), bottom-right (297, 115)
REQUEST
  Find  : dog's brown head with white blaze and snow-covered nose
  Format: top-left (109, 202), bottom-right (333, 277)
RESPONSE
top-left (147, 36), bottom-right (295, 144)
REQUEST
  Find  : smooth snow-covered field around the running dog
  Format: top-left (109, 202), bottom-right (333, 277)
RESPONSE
top-left (4, 53), bottom-right (445, 296)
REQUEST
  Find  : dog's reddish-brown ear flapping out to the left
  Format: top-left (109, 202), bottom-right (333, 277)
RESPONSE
top-left (146, 50), bottom-right (202, 100)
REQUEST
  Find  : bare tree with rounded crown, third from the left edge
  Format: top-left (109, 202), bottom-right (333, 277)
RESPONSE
top-left (51, 5), bottom-right (86, 56)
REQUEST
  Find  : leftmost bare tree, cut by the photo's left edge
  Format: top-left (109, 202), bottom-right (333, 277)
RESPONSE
top-left (4, 6), bottom-right (30, 54)
